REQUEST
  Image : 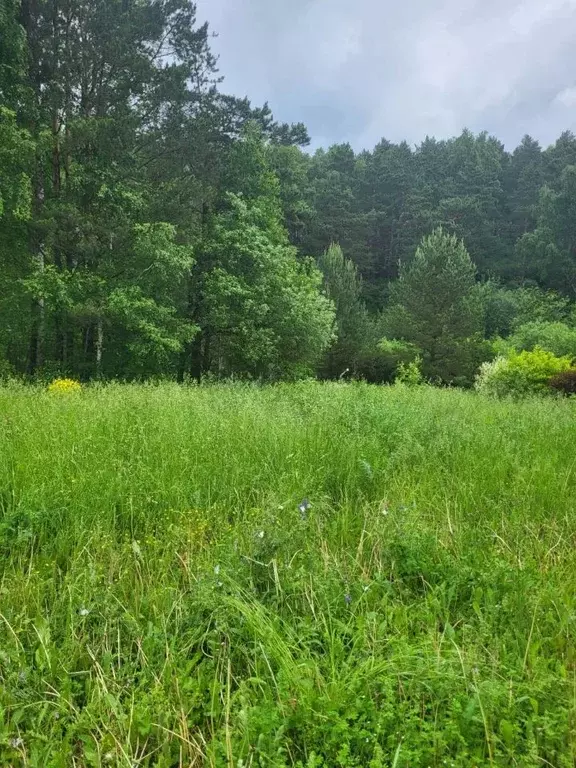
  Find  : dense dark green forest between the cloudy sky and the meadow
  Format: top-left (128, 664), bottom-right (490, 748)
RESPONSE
top-left (0, 0), bottom-right (576, 385)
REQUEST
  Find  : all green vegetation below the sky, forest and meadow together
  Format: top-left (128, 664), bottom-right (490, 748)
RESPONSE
top-left (0, 0), bottom-right (576, 768)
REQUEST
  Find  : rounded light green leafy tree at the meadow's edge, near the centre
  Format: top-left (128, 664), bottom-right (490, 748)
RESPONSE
top-left (201, 196), bottom-right (334, 378)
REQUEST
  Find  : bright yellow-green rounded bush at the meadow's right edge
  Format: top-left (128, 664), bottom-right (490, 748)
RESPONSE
top-left (476, 347), bottom-right (572, 397)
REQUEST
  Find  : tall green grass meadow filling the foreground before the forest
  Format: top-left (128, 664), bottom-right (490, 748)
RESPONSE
top-left (0, 383), bottom-right (576, 768)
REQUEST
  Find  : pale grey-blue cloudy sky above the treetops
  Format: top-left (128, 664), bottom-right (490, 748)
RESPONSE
top-left (197, 0), bottom-right (576, 149)
